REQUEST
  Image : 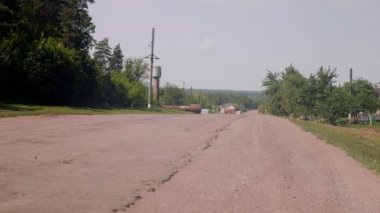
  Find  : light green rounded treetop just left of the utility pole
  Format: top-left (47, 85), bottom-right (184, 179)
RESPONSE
top-left (124, 58), bottom-right (148, 81)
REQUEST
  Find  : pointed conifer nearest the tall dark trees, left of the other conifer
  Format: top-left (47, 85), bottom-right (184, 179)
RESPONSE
top-left (94, 38), bottom-right (111, 74)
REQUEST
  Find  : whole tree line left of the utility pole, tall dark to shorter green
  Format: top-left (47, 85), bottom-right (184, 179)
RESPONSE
top-left (0, 0), bottom-right (146, 107)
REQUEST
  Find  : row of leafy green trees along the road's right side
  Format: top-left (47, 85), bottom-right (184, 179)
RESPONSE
top-left (259, 65), bottom-right (380, 124)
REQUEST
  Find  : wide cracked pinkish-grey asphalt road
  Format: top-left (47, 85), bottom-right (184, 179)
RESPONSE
top-left (0, 112), bottom-right (380, 213)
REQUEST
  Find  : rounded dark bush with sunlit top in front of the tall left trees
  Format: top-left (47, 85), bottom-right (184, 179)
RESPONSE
top-left (24, 39), bottom-right (80, 105)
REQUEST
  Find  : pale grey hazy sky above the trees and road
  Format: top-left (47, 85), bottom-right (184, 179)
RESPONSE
top-left (90, 0), bottom-right (380, 90)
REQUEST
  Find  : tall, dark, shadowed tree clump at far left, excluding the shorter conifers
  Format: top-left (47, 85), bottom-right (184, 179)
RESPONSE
top-left (0, 0), bottom-right (97, 104)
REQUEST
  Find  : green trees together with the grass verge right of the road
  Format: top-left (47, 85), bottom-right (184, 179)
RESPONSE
top-left (259, 65), bottom-right (380, 173)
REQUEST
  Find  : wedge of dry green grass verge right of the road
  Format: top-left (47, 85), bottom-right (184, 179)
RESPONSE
top-left (292, 119), bottom-right (380, 174)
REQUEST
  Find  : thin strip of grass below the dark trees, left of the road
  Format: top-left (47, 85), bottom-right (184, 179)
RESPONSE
top-left (0, 104), bottom-right (187, 117)
